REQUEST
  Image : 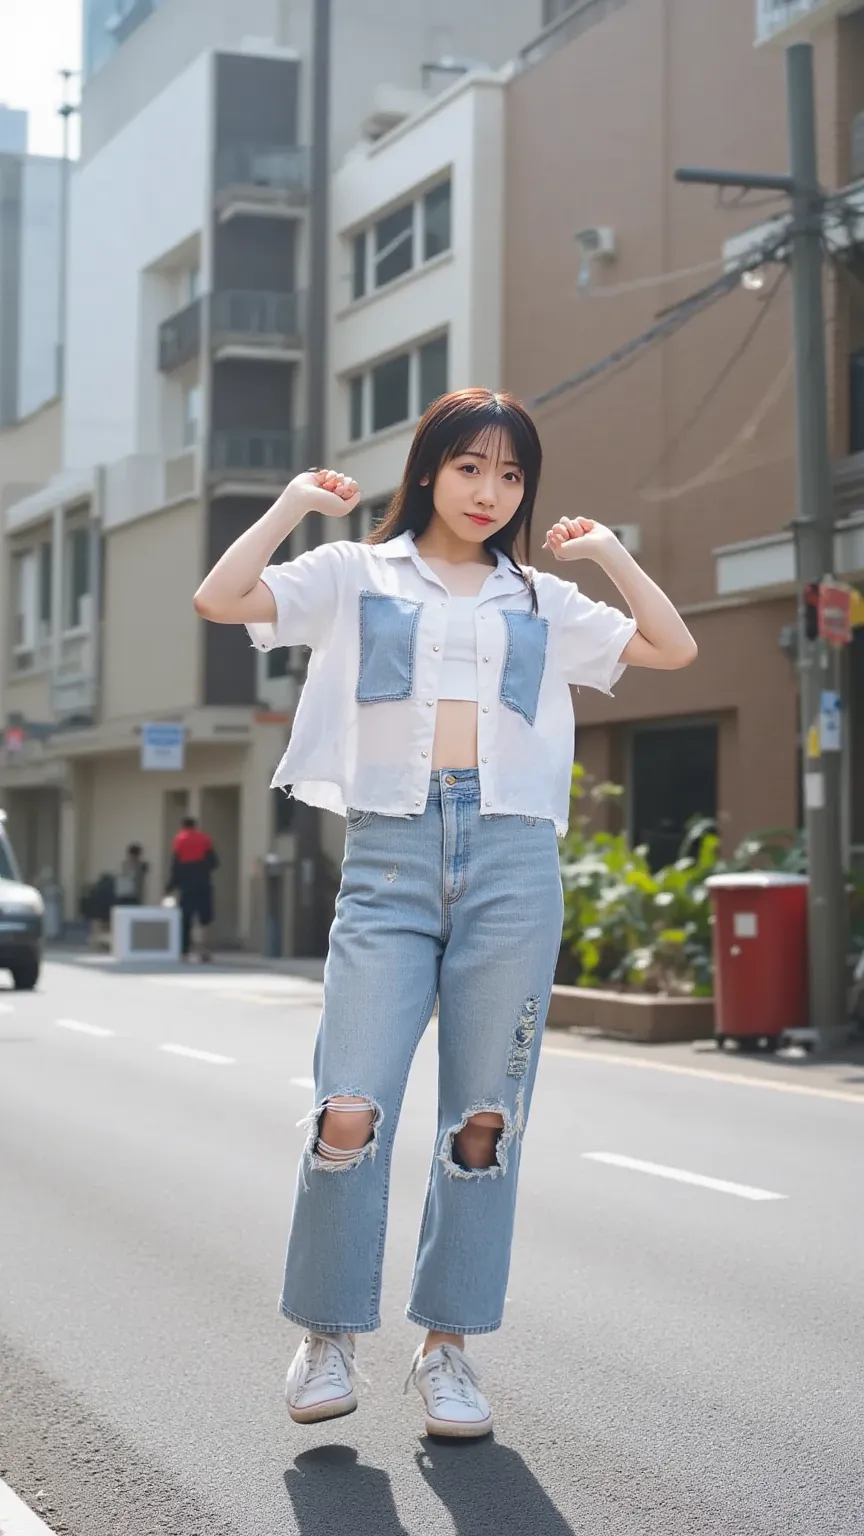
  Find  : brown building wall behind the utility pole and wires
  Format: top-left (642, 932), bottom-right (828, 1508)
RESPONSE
top-left (504, 0), bottom-right (864, 859)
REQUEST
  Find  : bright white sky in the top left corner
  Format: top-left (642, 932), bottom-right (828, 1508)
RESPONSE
top-left (0, 0), bottom-right (81, 155)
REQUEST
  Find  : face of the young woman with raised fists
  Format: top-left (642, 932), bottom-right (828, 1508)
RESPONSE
top-left (432, 433), bottom-right (524, 545)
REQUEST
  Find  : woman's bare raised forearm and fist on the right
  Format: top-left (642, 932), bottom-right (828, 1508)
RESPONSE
top-left (544, 518), bottom-right (698, 671)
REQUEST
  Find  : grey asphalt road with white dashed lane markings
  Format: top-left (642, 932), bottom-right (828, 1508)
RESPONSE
top-left (0, 965), bottom-right (864, 1536)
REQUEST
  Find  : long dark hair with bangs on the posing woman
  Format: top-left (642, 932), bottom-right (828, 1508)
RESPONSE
top-left (366, 389), bottom-right (543, 613)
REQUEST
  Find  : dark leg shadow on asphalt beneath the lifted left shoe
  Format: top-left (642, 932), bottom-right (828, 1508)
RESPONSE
top-left (284, 1445), bottom-right (409, 1536)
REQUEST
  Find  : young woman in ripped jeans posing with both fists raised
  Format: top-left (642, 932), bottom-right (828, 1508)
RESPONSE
top-left (195, 389), bottom-right (696, 1436)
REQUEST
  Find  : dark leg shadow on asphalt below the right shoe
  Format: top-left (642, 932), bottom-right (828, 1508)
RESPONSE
top-left (417, 1438), bottom-right (575, 1536)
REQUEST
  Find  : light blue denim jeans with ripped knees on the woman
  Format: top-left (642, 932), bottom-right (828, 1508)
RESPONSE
top-left (281, 770), bottom-right (563, 1333)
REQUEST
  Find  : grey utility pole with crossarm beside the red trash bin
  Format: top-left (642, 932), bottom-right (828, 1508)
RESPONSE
top-left (676, 43), bottom-right (847, 1051)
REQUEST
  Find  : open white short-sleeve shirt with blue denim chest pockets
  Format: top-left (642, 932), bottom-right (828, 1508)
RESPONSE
top-left (248, 533), bottom-right (636, 837)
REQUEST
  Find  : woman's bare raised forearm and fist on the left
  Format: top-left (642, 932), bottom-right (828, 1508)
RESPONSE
top-left (192, 470), bottom-right (360, 624)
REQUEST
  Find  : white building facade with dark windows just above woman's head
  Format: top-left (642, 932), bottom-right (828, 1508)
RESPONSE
top-left (329, 69), bottom-right (509, 516)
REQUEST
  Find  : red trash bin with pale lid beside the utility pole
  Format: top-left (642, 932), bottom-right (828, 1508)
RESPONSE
top-left (707, 869), bottom-right (810, 1049)
